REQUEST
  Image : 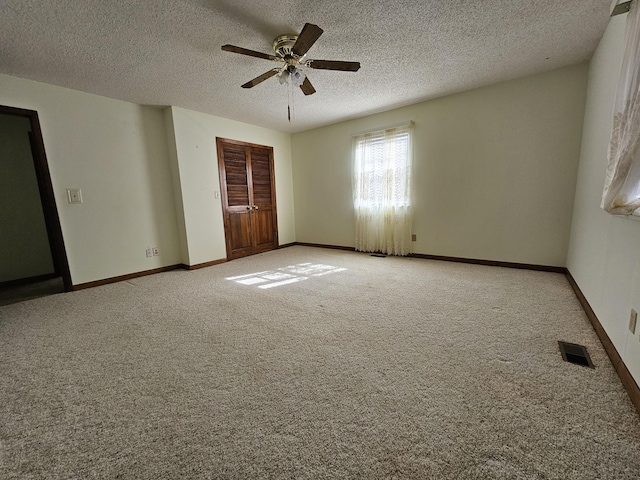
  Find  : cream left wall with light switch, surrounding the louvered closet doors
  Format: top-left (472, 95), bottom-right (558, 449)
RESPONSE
top-left (0, 75), bottom-right (295, 285)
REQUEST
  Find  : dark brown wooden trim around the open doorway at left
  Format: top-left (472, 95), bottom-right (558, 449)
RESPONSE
top-left (0, 105), bottom-right (73, 292)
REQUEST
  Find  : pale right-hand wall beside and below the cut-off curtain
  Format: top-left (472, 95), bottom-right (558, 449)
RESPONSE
top-left (567, 15), bottom-right (640, 383)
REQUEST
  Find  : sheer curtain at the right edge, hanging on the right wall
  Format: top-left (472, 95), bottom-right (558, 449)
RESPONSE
top-left (601, 0), bottom-right (640, 215)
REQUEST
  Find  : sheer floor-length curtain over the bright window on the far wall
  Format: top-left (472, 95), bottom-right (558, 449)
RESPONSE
top-left (353, 125), bottom-right (412, 255)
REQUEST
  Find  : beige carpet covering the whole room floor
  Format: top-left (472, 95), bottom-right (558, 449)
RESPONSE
top-left (0, 247), bottom-right (640, 480)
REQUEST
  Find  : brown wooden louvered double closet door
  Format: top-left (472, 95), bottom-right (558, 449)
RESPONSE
top-left (216, 138), bottom-right (278, 259)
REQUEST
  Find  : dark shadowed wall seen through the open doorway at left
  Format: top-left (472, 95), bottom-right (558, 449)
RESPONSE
top-left (0, 115), bottom-right (55, 282)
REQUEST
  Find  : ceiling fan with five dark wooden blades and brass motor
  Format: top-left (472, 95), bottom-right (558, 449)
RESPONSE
top-left (222, 23), bottom-right (360, 95)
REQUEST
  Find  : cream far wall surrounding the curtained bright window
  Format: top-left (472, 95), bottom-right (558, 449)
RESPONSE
top-left (292, 64), bottom-right (587, 266)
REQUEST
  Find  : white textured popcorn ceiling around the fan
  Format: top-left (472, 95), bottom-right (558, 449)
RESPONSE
top-left (0, 0), bottom-right (611, 132)
